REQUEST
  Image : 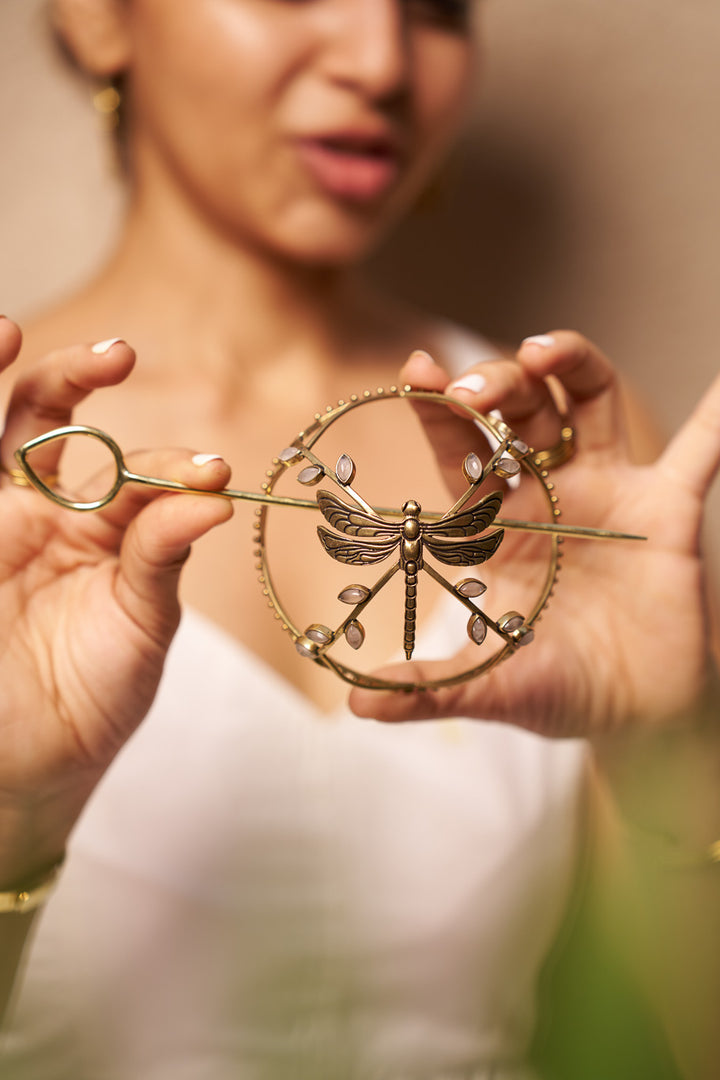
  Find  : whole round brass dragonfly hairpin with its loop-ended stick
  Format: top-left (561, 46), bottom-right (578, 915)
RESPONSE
top-left (11, 387), bottom-right (642, 690)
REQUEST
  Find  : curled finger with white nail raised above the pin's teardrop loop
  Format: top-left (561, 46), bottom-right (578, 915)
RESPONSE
top-left (0, 338), bottom-right (135, 473)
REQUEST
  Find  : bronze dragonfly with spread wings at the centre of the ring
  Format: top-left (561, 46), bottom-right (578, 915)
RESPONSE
top-left (317, 491), bottom-right (503, 660)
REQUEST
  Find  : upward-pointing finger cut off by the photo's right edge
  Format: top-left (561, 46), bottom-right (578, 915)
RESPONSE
top-left (657, 376), bottom-right (720, 498)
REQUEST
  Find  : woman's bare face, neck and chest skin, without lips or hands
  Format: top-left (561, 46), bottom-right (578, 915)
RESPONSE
top-left (18, 0), bottom-right (475, 708)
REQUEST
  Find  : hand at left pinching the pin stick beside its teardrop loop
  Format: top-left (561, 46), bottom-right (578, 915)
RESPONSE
top-left (0, 319), bottom-right (232, 888)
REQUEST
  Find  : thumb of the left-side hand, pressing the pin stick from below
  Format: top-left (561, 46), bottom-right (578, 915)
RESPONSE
top-left (116, 477), bottom-right (233, 643)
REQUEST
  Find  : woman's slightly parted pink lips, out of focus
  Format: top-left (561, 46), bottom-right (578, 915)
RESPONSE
top-left (297, 136), bottom-right (399, 203)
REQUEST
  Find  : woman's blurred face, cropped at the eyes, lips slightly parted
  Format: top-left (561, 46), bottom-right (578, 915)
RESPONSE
top-left (117, 0), bottom-right (474, 265)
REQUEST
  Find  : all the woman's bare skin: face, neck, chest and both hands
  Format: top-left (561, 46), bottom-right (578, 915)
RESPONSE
top-left (0, 0), bottom-right (720, 1076)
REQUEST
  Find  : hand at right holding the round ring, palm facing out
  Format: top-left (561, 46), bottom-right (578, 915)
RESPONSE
top-left (350, 330), bottom-right (720, 738)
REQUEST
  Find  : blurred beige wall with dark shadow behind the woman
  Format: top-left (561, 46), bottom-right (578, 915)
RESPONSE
top-left (0, 0), bottom-right (720, 548)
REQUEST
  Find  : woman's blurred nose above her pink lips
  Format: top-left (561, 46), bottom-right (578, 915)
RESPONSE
top-left (325, 0), bottom-right (410, 100)
